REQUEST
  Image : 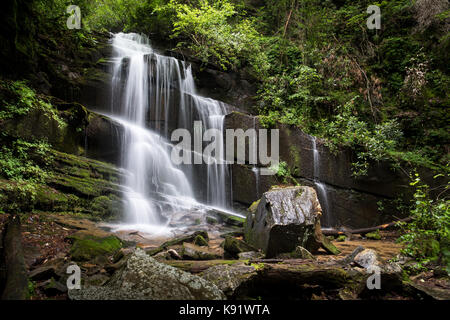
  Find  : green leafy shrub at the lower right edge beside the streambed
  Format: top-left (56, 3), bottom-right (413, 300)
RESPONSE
top-left (399, 174), bottom-right (450, 273)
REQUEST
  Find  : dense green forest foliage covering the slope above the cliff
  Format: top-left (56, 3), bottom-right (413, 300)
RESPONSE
top-left (34, 0), bottom-right (450, 175)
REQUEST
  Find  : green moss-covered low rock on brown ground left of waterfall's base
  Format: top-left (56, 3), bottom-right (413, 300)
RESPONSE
top-left (69, 236), bottom-right (122, 261)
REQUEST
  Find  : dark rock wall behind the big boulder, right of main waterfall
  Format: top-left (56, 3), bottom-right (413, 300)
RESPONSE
top-left (225, 112), bottom-right (437, 228)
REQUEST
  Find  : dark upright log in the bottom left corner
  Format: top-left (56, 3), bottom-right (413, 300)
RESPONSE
top-left (1, 215), bottom-right (28, 300)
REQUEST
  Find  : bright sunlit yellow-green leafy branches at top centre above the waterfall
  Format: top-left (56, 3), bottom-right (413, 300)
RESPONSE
top-left (160, 0), bottom-right (266, 75)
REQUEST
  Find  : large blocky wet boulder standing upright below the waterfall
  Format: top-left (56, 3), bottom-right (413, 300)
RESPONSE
top-left (245, 187), bottom-right (322, 258)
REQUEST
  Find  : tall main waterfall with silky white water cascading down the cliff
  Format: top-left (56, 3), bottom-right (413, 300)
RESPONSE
top-left (110, 33), bottom-right (231, 232)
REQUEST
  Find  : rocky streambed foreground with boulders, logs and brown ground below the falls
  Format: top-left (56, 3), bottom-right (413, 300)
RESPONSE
top-left (1, 187), bottom-right (450, 300)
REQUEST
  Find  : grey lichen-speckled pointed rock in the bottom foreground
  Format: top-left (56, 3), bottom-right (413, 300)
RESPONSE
top-left (69, 249), bottom-right (225, 300)
